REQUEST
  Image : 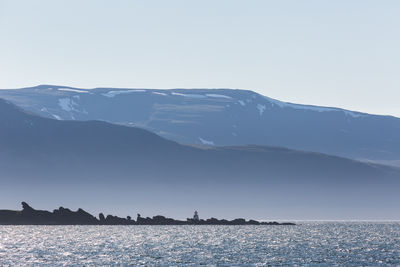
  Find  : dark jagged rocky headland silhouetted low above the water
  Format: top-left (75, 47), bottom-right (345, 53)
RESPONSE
top-left (0, 202), bottom-right (295, 225)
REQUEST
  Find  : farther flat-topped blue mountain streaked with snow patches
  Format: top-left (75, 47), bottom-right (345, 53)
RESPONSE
top-left (0, 85), bottom-right (400, 162)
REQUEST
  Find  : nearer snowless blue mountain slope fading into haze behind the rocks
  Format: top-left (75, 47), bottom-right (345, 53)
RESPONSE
top-left (0, 96), bottom-right (400, 220)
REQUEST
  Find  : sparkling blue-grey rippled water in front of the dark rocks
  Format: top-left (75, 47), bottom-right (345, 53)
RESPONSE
top-left (0, 222), bottom-right (400, 266)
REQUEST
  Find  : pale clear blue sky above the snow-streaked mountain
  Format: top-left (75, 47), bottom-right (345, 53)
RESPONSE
top-left (0, 0), bottom-right (400, 116)
